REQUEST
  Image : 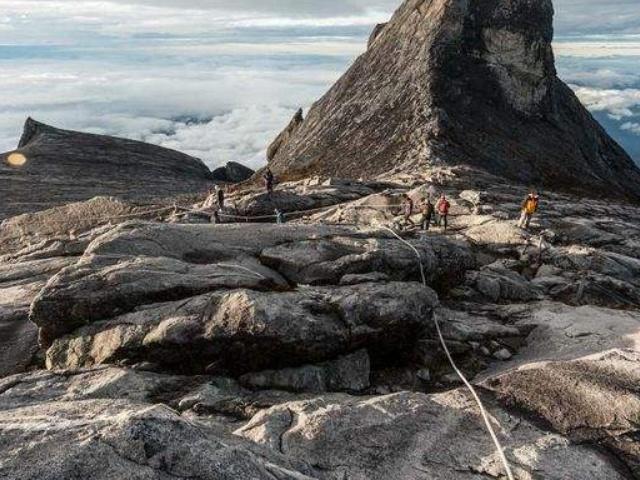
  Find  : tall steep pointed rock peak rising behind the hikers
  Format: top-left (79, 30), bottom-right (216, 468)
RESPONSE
top-left (271, 0), bottom-right (640, 199)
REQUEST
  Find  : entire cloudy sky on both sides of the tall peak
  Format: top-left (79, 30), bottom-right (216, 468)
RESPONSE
top-left (0, 0), bottom-right (640, 166)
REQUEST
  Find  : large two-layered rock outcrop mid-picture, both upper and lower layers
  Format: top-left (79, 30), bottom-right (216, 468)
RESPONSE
top-left (30, 223), bottom-right (456, 375)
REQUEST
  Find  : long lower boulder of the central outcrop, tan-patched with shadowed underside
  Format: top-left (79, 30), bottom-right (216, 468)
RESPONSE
top-left (45, 283), bottom-right (437, 376)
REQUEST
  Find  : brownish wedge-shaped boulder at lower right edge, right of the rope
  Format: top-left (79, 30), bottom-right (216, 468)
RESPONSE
top-left (485, 350), bottom-right (640, 477)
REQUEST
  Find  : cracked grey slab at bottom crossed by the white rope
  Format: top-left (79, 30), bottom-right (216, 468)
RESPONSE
top-left (235, 390), bottom-right (626, 480)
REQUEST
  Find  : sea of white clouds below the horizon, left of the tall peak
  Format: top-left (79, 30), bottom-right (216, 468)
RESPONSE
top-left (0, 42), bottom-right (351, 168)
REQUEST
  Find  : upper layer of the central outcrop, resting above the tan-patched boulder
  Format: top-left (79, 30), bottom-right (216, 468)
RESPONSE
top-left (31, 223), bottom-right (473, 347)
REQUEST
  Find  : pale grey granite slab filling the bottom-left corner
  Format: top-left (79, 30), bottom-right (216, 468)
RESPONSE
top-left (0, 368), bottom-right (317, 480)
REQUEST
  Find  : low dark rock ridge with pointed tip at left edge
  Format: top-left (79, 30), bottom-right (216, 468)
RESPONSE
top-left (0, 119), bottom-right (211, 220)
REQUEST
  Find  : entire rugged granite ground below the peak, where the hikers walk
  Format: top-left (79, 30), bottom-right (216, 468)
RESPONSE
top-left (0, 173), bottom-right (640, 480)
